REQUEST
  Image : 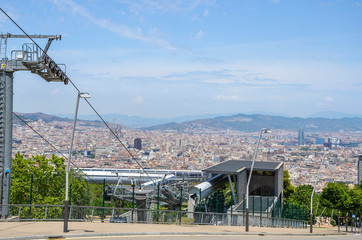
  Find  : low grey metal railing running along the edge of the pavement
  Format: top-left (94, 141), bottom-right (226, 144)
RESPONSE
top-left (0, 204), bottom-right (307, 228)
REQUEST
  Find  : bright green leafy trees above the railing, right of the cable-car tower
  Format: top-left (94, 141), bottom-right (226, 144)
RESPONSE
top-left (10, 153), bottom-right (89, 205)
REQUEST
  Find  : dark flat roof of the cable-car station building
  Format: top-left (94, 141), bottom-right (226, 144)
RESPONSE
top-left (202, 160), bottom-right (283, 175)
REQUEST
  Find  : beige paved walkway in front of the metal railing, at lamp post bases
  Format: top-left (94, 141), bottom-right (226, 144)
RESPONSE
top-left (0, 222), bottom-right (354, 239)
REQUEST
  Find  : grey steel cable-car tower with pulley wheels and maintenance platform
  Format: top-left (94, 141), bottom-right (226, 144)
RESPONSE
top-left (0, 33), bottom-right (69, 218)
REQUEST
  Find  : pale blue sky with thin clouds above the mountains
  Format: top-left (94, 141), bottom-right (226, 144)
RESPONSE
top-left (0, 0), bottom-right (362, 118)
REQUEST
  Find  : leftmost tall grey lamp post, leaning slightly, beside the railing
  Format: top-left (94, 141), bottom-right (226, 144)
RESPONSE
top-left (63, 92), bottom-right (90, 232)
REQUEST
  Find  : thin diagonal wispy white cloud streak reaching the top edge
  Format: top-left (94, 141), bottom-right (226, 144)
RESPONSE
top-left (51, 0), bottom-right (177, 50)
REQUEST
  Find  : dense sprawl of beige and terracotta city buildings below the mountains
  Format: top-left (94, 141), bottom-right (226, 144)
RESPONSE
top-left (13, 120), bottom-right (362, 191)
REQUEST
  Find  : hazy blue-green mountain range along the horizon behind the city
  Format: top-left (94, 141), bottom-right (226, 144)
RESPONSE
top-left (14, 113), bottom-right (362, 132)
